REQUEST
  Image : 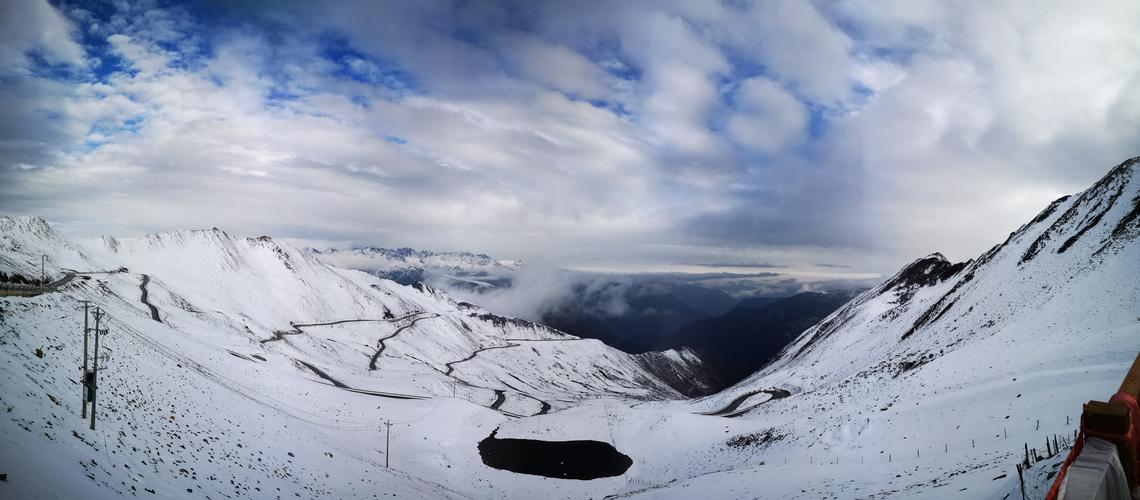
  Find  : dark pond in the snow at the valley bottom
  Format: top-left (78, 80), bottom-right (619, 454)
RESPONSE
top-left (479, 429), bottom-right (634, 479)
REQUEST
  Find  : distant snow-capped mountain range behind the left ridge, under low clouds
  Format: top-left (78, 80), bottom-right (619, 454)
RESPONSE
top-left (306, 246), bottom-right (521, 290)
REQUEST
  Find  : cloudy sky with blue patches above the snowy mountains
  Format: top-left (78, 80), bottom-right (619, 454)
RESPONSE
top-left (0, 0), bottom-right (1140, 273)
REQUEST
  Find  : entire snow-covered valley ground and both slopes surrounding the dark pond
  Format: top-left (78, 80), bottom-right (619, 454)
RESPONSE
top-left (0, 161), bottom-right (1140, 499)
